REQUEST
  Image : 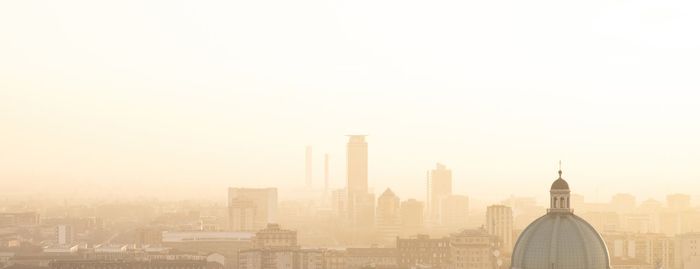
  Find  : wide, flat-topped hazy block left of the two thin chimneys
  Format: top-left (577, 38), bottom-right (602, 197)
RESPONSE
top-left (228, 188), bottom-right (277, 231)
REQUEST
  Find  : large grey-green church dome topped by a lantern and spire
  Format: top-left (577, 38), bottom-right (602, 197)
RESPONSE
top-left (511, 168), bottom-right (610, 269)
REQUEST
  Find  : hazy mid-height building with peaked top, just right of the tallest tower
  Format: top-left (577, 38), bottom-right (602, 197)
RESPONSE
top-left (376, 189), bottom-right (401, 243)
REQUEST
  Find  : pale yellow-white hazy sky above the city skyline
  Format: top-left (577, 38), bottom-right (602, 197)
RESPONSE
top-left (0, 0), bottom-right (700, 200)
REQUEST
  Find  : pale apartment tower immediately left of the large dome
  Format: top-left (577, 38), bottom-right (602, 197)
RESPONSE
top-left (486, 205), bottom-right (513, 253)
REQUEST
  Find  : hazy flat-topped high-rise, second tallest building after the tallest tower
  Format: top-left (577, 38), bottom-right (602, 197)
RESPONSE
top-left (427, 163), bottom-right (452, 221)
